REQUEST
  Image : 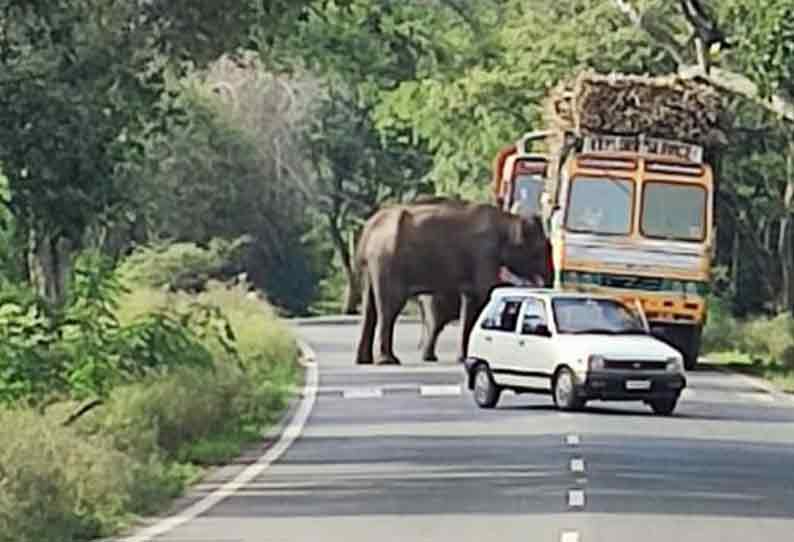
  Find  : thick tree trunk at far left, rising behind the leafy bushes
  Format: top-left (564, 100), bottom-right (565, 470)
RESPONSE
top-left (28, 228), bottom-right (74, 307)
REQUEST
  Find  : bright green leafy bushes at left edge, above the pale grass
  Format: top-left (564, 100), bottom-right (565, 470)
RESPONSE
top-left (0, 254), bottom-right (228, 404)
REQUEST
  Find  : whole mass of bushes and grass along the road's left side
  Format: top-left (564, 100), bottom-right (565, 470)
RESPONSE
top-left (0, 245), bottom-right (301, 542)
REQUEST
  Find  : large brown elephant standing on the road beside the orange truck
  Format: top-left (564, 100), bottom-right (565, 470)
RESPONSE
top-left (356, 198), bottom-right (548, 364)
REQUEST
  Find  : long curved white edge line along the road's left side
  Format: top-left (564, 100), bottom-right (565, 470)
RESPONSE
top-left (119, 346), bottom-right (318, 542)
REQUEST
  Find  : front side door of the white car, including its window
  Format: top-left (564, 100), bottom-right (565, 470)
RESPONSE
top-left (510, 296), bottom-right (556, 389)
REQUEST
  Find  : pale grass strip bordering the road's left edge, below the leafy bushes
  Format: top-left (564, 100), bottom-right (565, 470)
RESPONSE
top-left (0, 285), bottom-right (302, 542)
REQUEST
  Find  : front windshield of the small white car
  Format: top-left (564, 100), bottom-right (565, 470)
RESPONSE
top-left (552, 297), bottom-right (647, 335)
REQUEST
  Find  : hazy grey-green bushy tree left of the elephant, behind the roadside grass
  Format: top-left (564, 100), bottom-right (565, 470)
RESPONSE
top-left (136, 78), bottom-right (318, 313)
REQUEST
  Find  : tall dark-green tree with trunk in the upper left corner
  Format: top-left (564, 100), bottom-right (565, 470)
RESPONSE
top-left (0, 0), bottom-right (322, 305)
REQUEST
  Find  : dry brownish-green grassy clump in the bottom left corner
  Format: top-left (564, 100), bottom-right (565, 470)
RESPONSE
top-left (0, 410), bottom-right (180, 542)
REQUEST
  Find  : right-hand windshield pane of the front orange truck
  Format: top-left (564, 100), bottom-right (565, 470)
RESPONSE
top-left (641, 182), bottom-right (706, 241)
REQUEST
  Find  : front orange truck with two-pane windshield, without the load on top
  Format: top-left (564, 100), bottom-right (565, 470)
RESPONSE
top-left (544, 134), bottom-right (715, 370)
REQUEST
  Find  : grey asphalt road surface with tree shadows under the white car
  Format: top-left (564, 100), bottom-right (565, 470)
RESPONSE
top-left (142, 324), bottom-right (794, 542)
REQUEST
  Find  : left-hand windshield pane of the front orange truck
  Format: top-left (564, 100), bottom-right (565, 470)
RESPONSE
top-left (565, 177), bottom-right (634, 235)
